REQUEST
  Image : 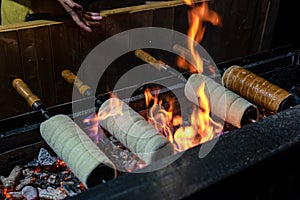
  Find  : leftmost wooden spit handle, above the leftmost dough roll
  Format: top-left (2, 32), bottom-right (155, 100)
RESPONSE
top-left (12, 78), bottom-right (41, 108)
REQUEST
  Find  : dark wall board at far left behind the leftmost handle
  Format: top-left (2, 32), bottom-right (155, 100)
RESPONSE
top-left (0, 31), bottom-right (26, 119)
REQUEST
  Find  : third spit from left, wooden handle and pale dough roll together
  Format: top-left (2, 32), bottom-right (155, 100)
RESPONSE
top-left (135, 49), bottom-right (259, 128)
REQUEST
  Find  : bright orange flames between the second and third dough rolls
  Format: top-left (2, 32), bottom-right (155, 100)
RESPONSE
top-left (144, 84), bottom-right (223, 152)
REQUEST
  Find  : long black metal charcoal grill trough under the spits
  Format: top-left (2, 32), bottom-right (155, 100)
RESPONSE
top-left (0, 46), bottom-right (300, 199)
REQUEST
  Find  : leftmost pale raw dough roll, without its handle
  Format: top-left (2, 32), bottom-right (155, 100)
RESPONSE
top-left (40, 114), bottom-right (116, 187)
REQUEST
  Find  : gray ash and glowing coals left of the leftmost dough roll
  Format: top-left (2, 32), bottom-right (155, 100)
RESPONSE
top-left (0, 148), bottom-right (86, 200)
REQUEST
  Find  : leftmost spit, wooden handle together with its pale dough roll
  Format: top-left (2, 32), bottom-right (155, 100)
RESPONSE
top-left (13, 79), bottom-right (116, 188)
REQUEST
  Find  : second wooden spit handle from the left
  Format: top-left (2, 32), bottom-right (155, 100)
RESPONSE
top-left (61, 69), bottom-right (91, 96)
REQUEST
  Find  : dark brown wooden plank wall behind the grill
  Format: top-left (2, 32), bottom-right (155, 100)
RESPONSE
top-left (0, 0), bottom-right (279, 119)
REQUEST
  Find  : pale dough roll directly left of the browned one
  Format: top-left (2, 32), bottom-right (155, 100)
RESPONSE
top-left (184, 74), bottom-right (259, 128)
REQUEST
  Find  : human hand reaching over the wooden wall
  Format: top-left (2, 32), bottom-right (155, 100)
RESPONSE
top-left (58, 0), bottom-right (102, 32)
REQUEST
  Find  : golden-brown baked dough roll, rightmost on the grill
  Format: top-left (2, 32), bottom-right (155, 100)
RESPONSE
top-left (222, 65), bottom-right (295, 112)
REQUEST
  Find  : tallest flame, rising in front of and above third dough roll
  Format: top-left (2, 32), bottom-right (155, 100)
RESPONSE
top-left (174, 0), bottom-right (223, 151)
